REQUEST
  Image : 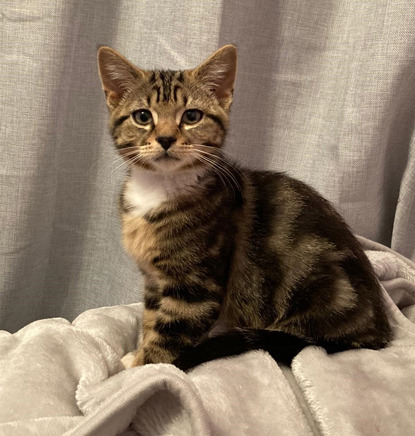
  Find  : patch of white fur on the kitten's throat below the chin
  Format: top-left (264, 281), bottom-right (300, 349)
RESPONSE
top-left (124, 168), bottom-right (206, 216)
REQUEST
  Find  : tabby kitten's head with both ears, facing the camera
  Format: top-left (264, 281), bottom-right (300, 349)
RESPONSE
top-left (98, 45), bottom-right (236, 172)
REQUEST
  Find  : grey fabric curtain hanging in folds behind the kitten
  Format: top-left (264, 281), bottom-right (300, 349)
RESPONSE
top-left (0, 0), bottom-right (415, 331)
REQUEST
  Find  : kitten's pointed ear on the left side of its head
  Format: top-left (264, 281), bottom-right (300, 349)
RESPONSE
top-left (98, 46), bottom-right (145, 109)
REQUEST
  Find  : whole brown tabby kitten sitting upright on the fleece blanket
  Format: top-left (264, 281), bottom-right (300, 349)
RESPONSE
top-left (98, 45), bottom-right (391, 369)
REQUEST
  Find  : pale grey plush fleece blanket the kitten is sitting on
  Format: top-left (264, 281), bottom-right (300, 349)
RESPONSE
top-left (0, 238), bottom-right (415, 436)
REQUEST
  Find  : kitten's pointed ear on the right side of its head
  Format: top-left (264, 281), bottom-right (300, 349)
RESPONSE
top-left (193, 44), bottom-right (237, 100)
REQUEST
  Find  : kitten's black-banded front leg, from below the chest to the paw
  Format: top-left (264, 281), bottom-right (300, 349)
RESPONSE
top-left (133, 284), bottom-right (223, 366)
